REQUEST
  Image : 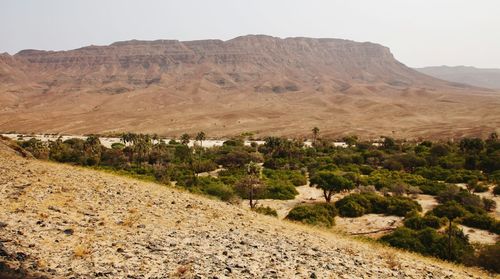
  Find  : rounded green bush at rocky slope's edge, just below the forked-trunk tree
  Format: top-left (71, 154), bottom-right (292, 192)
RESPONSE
top-left (286, 203), bottom-right (337, 227)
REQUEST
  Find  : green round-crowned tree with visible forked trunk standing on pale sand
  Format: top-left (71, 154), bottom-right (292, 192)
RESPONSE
top-left (311, 171), bottom-right (354, 202)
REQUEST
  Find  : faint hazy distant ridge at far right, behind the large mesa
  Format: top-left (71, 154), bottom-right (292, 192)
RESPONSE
top-left (416, 66), bottom-right (500, 89)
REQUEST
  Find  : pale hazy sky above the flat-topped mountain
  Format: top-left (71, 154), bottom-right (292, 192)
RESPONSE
top-left (0, 0), bottom-right (500, 68)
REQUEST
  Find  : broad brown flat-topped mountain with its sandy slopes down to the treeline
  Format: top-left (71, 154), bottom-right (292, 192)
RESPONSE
top-left (0, 35), bottom-right (500, 137)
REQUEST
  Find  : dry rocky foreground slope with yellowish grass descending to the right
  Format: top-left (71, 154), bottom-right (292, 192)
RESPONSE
top-left (0, 143), bottom-right (487, 278)
